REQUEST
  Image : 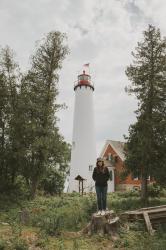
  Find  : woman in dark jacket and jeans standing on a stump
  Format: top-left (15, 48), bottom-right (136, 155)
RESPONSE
top-left (92, 158), bottom-right (109, 215)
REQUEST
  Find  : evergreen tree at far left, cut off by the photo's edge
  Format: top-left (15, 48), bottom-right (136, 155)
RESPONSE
top-left (0, 46), bottom-right (20, 186)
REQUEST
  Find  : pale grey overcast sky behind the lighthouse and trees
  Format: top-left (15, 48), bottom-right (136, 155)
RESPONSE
top-left (0, 0), bottom-right (166, 154)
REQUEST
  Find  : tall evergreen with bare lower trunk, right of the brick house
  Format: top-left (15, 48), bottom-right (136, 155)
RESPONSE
top-left (125, 25), bottom-right (166, 202)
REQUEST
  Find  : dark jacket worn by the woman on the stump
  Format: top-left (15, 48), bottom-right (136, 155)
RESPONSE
top-left (92, 167), bottom-right (109, 187)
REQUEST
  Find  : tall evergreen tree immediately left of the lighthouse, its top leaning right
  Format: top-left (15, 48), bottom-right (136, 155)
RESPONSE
top-left (20, 32), bottom-right (68, 197)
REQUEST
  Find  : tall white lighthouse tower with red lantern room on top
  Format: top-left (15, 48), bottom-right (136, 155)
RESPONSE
top-left (68, 71), bottom-right (96, 192)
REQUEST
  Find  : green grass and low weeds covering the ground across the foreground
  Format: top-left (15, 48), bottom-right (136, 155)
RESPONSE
top-left (0, 192), bottom-right (166, 250)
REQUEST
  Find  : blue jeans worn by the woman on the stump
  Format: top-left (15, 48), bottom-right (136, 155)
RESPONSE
top-left (95, 186), bottom-right (107, 210)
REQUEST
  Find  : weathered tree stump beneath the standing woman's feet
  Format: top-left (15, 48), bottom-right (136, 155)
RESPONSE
top-left (81, 210), bottom-right (119, 235)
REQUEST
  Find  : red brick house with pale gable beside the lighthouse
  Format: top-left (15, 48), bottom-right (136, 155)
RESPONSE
top-left (100, 140), bottom-right (152, 192)
